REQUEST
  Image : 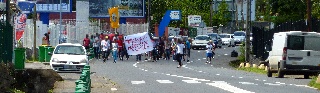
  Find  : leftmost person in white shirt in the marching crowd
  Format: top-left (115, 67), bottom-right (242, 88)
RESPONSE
top-left (101, 36), bottom-right (110, 63)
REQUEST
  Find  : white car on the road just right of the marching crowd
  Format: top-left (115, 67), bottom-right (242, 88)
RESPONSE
top-left (191, 35), bottom-right (210, 49)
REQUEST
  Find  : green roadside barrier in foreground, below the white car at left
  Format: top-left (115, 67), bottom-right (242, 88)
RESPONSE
top-left (75, 65), bottom-right (91, 93)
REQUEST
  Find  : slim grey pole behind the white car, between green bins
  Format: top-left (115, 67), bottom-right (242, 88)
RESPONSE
top-left (32, 3), bottom-right (37, 60)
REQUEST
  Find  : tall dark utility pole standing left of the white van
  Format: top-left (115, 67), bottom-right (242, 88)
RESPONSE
top-left (245, 0), bottom-right (251, 62)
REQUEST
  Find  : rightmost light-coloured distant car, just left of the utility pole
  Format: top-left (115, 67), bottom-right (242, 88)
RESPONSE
top-left (233, 31), bottom-right (246, 45)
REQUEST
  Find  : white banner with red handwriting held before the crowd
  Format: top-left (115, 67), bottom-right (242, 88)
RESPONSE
top-left (124, 32), bottom-right (153, 55)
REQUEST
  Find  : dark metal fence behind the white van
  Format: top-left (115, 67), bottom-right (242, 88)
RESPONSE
top-left (252, 19), bottom-right (320, 60)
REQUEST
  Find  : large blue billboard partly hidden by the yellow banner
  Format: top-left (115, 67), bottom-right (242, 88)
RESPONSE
top-left (89, 0), bottom-right (145, 18)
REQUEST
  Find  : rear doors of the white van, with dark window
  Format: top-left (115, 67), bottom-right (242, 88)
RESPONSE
top-left (286, 35), bottom-right (320, 66)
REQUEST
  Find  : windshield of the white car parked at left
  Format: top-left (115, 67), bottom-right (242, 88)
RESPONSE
top-left (54, 45), bottom-right (85, 55)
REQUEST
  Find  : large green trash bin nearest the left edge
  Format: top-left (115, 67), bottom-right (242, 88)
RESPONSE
top-left (14, 48), bottom-right (26, 69)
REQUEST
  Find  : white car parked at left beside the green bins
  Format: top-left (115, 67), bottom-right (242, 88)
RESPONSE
top-left (49, 43), bottom-right (90, 72)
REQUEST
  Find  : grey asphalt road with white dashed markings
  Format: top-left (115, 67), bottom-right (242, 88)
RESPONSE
top-left (90, 46), bottom-right (319, 93)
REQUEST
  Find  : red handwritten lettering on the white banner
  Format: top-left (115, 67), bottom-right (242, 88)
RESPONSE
top-left (125, 36), bottom-right (150, 51)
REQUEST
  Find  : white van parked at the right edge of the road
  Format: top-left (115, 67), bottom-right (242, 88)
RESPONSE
top-left (266, 31), bottom-right (320, 78)
